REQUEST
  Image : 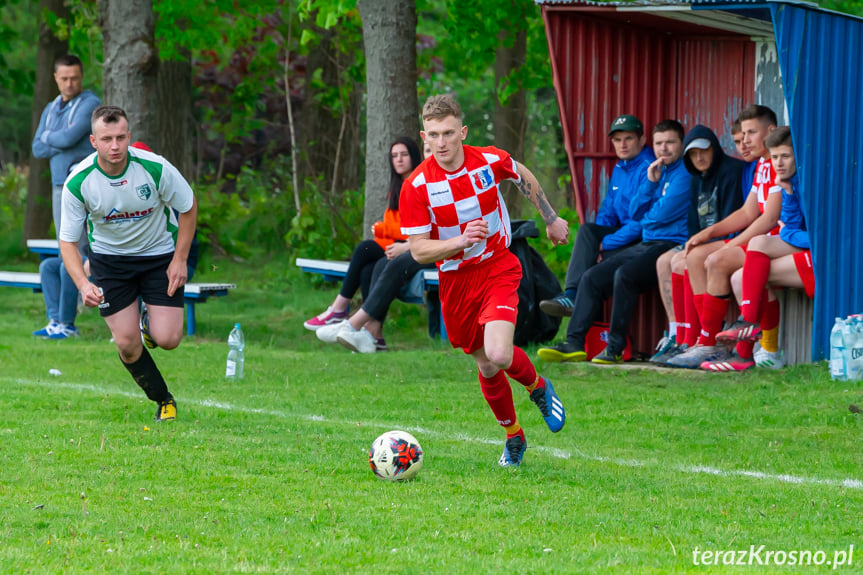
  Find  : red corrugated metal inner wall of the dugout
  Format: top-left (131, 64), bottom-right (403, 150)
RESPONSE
top-left (542, 5), bottom-right (755, 354)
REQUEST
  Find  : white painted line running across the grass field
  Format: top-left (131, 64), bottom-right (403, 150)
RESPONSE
top-left (11, 378), bottom-right (863, 490)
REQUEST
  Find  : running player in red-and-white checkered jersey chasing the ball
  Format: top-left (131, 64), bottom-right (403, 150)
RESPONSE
top-left (399, 95), bottom-right (569, 467)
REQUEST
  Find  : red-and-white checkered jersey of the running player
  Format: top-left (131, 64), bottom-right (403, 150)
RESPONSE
top-left (399, 146), bottom-right (521, 272)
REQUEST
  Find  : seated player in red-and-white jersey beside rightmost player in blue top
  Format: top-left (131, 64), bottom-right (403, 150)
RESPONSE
top-left (669, 105), bottom-right (782, 371)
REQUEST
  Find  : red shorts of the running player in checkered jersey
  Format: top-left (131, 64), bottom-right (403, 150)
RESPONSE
top-left (439, 250), bottom-right (521, 354)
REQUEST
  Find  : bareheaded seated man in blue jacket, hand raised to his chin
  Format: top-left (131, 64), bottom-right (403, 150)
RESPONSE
top-left (539, 120), bottom-right (690, 364)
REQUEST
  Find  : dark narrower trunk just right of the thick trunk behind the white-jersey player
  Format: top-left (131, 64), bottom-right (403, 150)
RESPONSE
top-left (159, 53), bottom-right (193, 181)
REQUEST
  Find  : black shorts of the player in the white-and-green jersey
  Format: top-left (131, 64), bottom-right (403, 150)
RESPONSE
top-left (90, 252), bottom-right (184, 317)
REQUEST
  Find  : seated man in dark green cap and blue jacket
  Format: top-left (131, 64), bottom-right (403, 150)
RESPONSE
top-left (539, 114), bottom-right (656, 317)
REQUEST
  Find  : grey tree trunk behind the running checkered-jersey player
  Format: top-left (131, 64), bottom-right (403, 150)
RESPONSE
top-left (357, 0), bottom-right (419, 237)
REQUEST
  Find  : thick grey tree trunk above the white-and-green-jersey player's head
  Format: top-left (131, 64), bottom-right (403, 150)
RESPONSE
top-left (99, 0), bottom-right (159, 147)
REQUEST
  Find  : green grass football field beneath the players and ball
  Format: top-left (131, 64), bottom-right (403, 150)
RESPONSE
top-left (0, 263), bottom-right (863, 574)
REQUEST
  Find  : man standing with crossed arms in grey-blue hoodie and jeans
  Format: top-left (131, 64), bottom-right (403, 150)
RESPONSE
top-left (33, 54), bottom-right (101, 339)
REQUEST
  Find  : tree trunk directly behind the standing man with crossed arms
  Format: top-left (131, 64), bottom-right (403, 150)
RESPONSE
top-left (22, 0), bottom-right (69, 241)
